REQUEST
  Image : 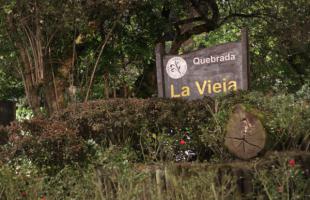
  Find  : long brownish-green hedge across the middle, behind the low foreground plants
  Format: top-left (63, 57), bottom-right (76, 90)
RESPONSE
top-left (2, 92), bottom-right (310, 169)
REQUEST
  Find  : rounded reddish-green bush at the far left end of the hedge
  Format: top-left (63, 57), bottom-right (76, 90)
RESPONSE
top-left (2, 119), bottom-right (91, 173)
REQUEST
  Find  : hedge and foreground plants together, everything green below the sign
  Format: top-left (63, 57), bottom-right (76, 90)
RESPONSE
top-left (0, 92), bottom-right (310, 199)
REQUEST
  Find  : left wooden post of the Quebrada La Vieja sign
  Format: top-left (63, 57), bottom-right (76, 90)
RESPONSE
top-left (155, 43), bottom-right (165, 97)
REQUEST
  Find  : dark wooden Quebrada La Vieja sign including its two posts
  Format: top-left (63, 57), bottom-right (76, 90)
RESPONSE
top-left (156, 29), bottom-right (249, 99)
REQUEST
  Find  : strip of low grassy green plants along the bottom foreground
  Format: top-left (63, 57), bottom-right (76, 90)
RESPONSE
top-left (0, 152), bottom-right (310, 200)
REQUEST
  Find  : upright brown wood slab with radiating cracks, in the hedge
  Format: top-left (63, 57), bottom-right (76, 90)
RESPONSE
top-left (225, 104), bottom-right (266, 160)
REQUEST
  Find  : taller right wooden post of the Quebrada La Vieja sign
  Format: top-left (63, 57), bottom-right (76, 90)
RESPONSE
top-left (241, 28), bottom-right (250, 90)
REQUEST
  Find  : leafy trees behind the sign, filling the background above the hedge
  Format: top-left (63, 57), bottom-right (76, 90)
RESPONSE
top-left (0, 0), bottom-right (310, 114)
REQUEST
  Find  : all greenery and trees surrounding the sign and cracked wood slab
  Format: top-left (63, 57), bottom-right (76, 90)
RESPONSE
top-left (0, 0), bottom-right (310, 200)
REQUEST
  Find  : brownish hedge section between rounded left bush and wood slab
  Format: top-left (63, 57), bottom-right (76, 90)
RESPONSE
top-left (52, 98), bottom-right (214, 160)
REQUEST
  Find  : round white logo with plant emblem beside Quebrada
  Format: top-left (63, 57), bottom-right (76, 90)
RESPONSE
top-left (166, 57), bottom-right (187, 79)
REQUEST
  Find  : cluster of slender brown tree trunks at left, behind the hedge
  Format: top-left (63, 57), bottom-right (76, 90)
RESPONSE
top-left (7, 8), bottom-right (73, 115)
